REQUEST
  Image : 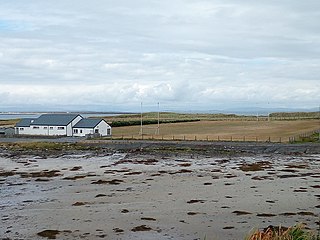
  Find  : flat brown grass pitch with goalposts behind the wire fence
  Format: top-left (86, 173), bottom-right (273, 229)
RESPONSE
top-left (113, 120), bottom-right (320, 142)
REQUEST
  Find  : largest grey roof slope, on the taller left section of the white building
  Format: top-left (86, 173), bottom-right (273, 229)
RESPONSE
top-left (31, 114), bottom-right (81, 126)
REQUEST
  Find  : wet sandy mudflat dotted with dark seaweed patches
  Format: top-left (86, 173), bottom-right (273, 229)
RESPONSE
top-left (0, 151), bottom-right (320, 240)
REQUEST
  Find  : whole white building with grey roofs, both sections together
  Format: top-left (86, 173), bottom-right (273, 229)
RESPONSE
top-left (15, 114), bottom-right (111, 136)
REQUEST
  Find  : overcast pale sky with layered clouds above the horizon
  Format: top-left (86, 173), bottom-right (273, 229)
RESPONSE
top-left (0, 0), bottom-right (320, 111)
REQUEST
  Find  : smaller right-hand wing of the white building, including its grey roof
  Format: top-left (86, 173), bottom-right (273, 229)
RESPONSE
top-left (73, 118), bottom-right (111, 136)
